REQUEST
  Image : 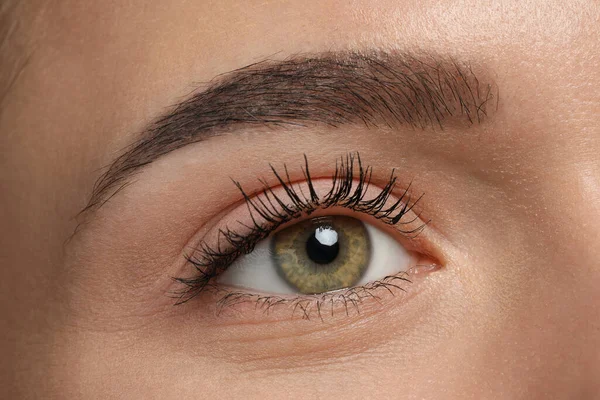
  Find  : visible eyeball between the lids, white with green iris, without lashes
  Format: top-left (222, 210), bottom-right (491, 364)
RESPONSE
top-left (218, 215), bottom-right (414, 295)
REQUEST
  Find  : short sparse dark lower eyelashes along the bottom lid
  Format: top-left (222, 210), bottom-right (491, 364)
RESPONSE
top-left (205, 272), bottom-right (412, 321)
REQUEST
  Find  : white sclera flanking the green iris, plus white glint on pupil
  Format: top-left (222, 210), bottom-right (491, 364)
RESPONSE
top-left (217, 223), bottom-right (414, 294)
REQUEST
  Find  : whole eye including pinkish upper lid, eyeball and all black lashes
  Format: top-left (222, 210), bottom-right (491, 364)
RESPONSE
top-left (174, 153), bottom-right (439, 319)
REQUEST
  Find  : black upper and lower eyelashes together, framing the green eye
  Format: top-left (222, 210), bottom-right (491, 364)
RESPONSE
top-left (173, 152), bottom-right (428, 308)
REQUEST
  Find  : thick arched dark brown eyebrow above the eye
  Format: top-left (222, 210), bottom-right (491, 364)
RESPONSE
top-left (84, 52), bottom-right (498, 211)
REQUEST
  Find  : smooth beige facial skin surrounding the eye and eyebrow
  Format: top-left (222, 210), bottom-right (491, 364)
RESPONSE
top-left (0, 0), bottom-right (600, 399)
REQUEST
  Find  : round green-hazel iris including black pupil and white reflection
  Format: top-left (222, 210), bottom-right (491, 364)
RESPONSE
top-left (272, 216), bottom-right (371, 294)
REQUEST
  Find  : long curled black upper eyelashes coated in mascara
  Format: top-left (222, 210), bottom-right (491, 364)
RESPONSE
top-left (173, 152), bottom-right (427, 305)
